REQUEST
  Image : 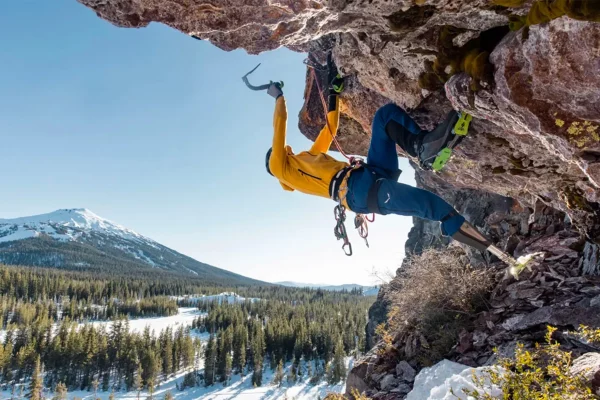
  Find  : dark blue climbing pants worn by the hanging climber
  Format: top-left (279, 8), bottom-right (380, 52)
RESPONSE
top-left (346, 104), bottom-right (465, 236)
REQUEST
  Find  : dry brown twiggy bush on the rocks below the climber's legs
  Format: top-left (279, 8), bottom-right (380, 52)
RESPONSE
top-left (388, 248), bottom-right (494, 365)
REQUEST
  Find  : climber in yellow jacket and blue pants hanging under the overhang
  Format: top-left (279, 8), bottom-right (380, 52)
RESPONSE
top-left (265, 55), bottom-right (500, 255)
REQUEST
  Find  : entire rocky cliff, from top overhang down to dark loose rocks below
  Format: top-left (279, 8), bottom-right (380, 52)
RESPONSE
top-left (72, 0), bottom-right (600, 398)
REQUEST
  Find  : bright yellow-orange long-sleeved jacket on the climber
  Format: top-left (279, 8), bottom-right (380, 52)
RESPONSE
top-left (269, 96), bottom-right (349, 198)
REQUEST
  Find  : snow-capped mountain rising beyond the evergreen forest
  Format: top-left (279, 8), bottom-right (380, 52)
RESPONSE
top-left (0, 208), bottom-right (264, 285)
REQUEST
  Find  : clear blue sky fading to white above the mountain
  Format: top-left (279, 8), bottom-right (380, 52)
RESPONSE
top-left (0, 0), bottom-right (414, 284)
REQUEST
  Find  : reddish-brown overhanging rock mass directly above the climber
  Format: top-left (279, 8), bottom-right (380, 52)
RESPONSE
top-left (78, 0), bottom-right (600, 231)
